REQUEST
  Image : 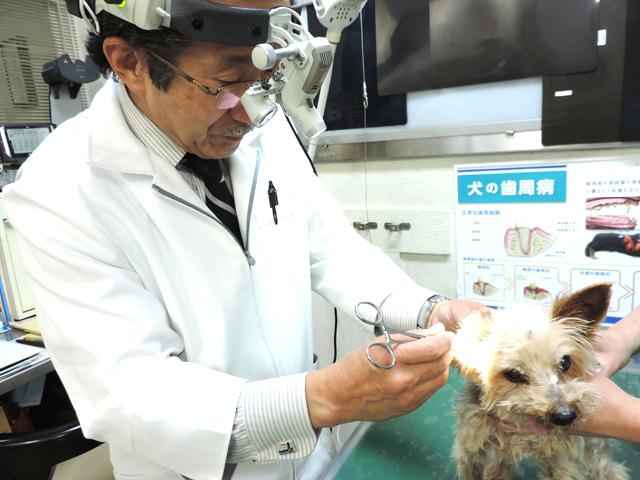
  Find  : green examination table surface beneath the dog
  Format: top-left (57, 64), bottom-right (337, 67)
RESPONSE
top-left (335, 373), bottom-right (640, 480)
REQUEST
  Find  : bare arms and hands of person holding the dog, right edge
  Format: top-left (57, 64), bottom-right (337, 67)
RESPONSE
top-left (581, 308), bottom-right (640, 442)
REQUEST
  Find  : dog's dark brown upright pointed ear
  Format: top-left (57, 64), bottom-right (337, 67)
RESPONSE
top-left (551, 283), bottom-right (611, 337)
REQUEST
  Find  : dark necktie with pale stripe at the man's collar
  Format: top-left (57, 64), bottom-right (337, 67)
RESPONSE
top-left (177, 153), bottom-right (243, 245)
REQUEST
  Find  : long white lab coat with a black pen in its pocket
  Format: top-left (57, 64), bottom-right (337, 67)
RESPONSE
top-left (4, 82), bottom-right (430, 480)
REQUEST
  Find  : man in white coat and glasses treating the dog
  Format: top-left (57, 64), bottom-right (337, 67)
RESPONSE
top-left (4, 0), bottom-right (479, 480)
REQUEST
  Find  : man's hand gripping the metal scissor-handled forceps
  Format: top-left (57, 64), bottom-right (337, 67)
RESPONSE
top-left (306, 327), bottom-right (453, 428)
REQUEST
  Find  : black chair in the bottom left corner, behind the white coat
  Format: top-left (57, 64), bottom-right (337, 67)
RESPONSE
top-left (0, 421), bottom-right (100, 480)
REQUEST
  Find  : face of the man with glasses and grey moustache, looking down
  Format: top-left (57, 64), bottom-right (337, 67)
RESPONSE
top-left (144, 0), bottom-right (288, 159)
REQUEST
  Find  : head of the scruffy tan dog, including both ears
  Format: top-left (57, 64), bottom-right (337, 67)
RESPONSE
top-left (454, 284), bottom-right (611, 426)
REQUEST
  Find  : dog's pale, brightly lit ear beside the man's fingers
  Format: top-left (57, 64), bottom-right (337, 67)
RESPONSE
top-left (452, 309), bottom-right (495, 385)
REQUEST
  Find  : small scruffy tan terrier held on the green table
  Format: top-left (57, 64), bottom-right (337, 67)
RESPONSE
top-left (453, 284), bottom-right (629, 480)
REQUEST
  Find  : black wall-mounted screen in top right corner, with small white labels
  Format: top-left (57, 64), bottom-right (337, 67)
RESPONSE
top-left (542, 0), bottom-right (640, 145)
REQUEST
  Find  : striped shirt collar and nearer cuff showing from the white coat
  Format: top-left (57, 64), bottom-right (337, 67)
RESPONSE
top-left (118, 83), bottom-right (317, 463)
